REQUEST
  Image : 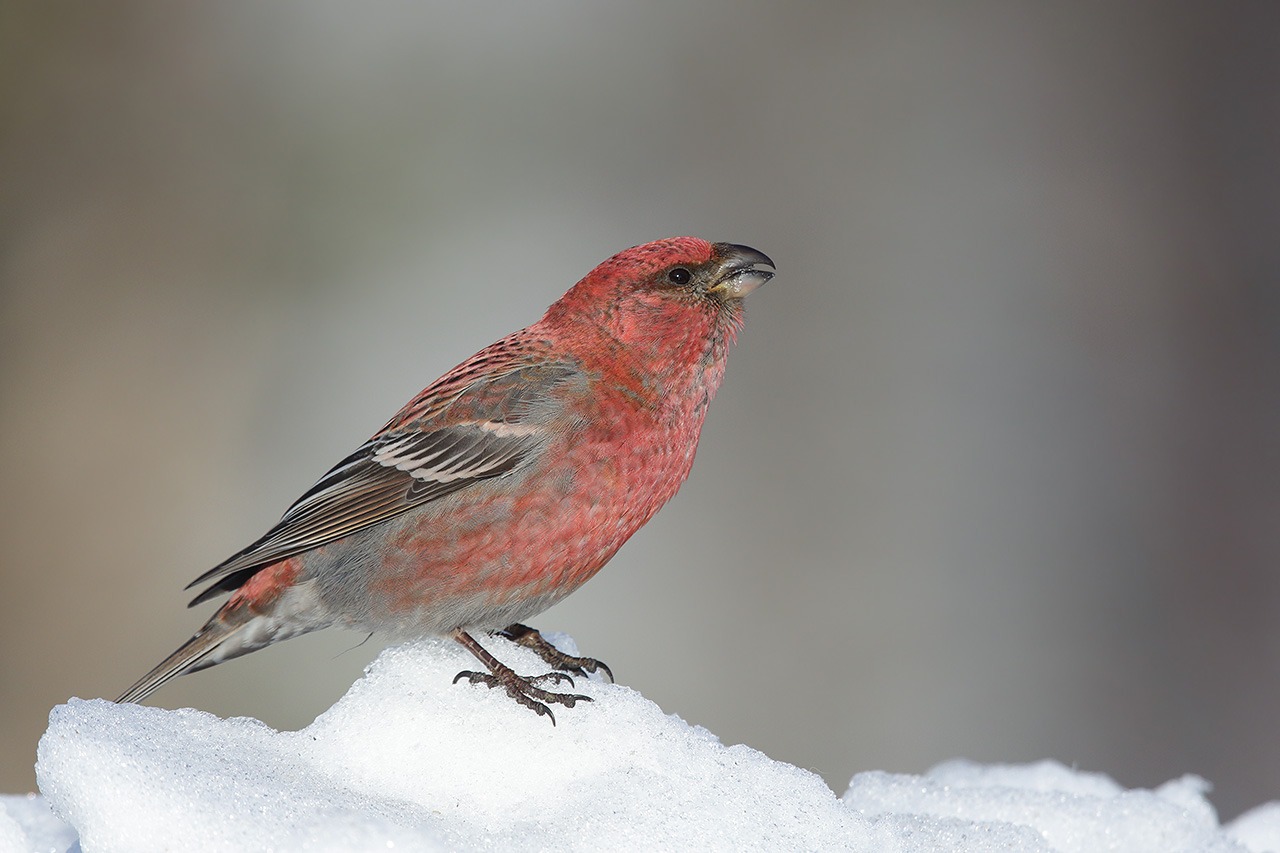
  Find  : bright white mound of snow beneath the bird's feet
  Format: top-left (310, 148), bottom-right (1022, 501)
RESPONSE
top-left (15, 635), bottom-right (1280, 853)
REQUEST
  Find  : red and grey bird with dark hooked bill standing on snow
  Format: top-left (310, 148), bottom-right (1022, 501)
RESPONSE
top-left (118, 237), bottom-right (773, 722)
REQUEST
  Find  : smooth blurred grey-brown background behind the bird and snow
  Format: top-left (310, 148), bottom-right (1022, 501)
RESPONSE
top-left (0, 0), bottom-right (1280, 817)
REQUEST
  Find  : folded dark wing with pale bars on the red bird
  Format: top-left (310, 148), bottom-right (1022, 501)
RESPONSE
top-left (187, 364), bottom-right (581, 605)
